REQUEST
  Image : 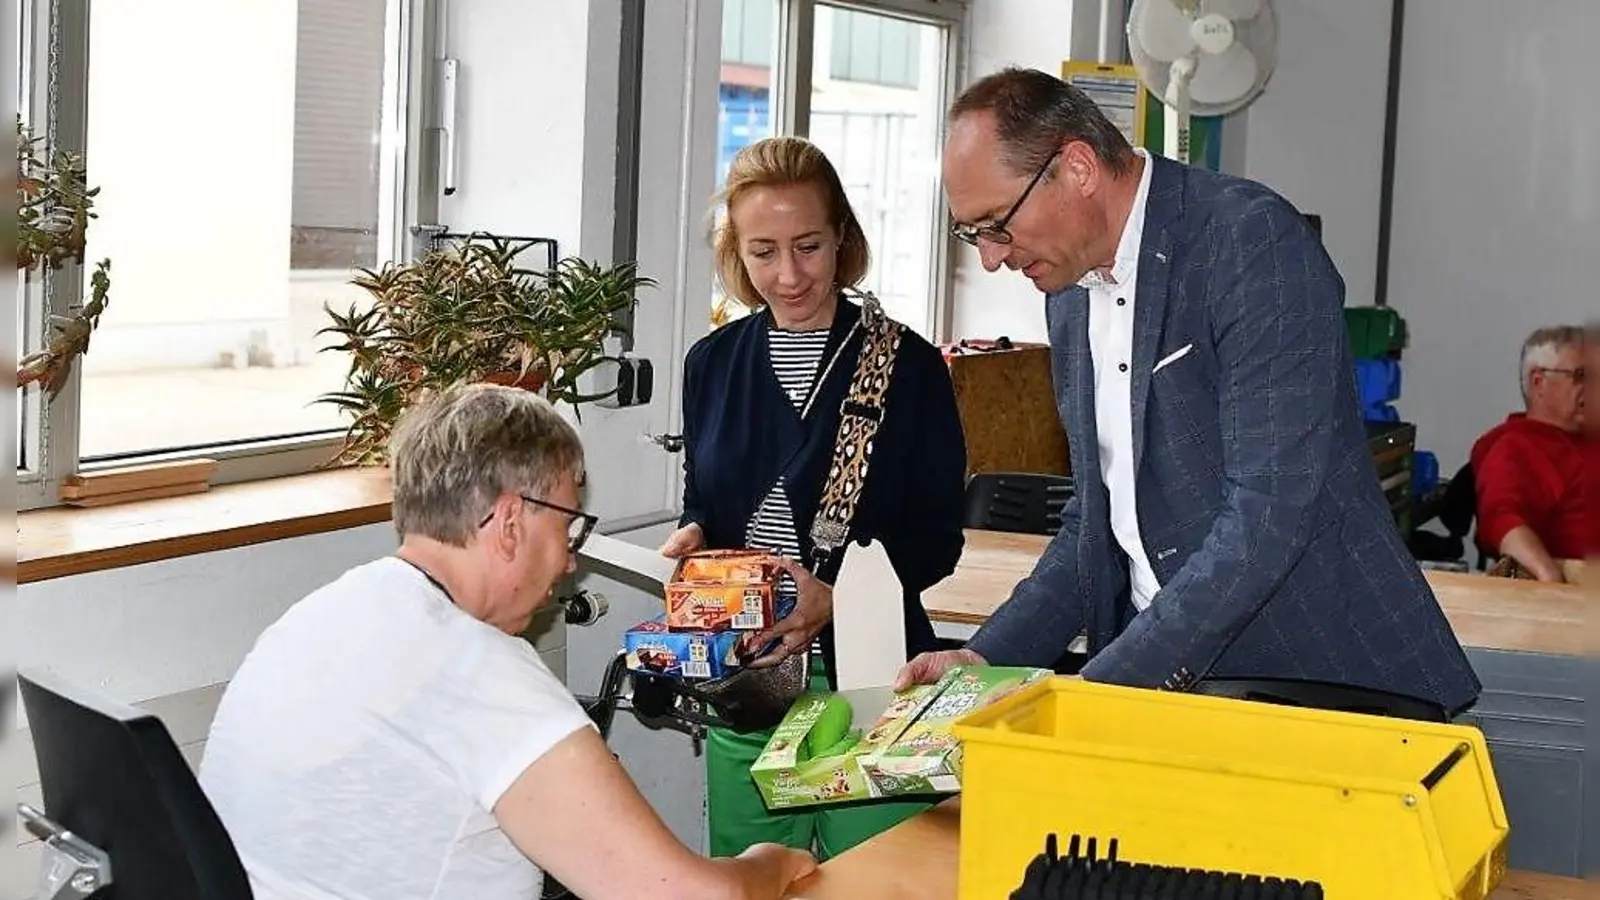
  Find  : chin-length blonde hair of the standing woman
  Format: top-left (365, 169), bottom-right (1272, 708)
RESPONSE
top-left (712, 138), bottom-right (872, 309)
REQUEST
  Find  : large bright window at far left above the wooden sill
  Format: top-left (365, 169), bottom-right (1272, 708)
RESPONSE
top-left (19, 0), bottom-right (422, 508)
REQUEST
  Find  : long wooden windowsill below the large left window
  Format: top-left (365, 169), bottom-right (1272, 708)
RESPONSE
top-left (16, 468), bottom-right (390, 585)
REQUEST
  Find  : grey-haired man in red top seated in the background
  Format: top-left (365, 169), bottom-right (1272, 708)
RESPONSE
top-left (1472, 327), bottom-right (1592, 581)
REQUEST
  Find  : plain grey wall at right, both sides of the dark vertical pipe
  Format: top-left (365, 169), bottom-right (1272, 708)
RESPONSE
top-left (1224, 0), bottom-right (1600, 474)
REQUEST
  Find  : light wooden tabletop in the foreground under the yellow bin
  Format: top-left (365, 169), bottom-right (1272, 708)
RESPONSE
top-left (789, 799), bottom-right (1600, 900)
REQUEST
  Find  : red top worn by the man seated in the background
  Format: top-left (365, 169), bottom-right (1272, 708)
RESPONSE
top-left (1472, 413), bottom-right (1595, 559)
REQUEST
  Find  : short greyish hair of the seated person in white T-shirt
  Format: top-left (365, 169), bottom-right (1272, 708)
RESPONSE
top-left (389, 384), bottom-right (584, 546)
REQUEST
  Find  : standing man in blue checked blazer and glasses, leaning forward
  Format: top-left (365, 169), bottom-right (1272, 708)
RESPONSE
top-left (901, 69), bottom-right (1480, 716)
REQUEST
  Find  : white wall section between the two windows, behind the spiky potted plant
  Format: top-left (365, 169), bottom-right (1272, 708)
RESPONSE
top-left (440, 0), bottom-right (722, 524)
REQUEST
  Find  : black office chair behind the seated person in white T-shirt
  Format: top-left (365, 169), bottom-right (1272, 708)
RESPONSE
top-left (18, 673), bottom-right (251, 900)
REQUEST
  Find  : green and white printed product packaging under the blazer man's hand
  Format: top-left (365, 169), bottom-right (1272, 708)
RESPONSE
top-left (750, 666), bottom-right (1051, 809)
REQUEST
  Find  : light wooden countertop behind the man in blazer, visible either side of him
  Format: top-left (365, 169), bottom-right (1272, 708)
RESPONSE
top-left (922, 530), bottom-right (1594, 657)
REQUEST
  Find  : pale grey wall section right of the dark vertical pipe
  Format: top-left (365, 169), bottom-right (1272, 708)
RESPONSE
top-left (1389, 0), bottom-right (1600, 474)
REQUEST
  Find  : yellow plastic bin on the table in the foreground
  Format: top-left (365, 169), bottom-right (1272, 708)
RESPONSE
top-left (954, 677), bottom-right (1510, 900)
